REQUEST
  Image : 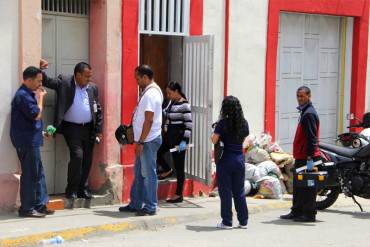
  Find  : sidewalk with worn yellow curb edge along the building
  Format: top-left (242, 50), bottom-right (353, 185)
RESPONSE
top-left (0, 197), bottom-right (370, 247)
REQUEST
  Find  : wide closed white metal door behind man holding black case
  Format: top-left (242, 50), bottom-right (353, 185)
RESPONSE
top-left (276, 13), bottom-right (340, 151)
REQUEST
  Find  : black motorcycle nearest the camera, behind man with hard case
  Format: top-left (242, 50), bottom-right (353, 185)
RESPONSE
top-left (316, 143), bottom-right (370, 212)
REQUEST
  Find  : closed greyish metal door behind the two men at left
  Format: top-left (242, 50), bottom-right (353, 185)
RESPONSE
top-left (41, 14), bottom-right (89, 194)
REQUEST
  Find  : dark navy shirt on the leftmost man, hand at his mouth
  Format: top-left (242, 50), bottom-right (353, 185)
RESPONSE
top-left (10, 85), bottom-right (43, 147)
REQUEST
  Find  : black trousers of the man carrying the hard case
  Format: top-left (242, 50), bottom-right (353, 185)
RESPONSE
top-left (292, 160), bottom-right (317, 218)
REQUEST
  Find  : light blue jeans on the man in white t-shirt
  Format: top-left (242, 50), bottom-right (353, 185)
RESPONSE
top-left (130, 136), bottom-right (162, 212)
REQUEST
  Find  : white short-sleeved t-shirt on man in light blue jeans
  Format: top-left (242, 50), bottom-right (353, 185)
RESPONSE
top-left (133, 86), bottom-right (163, 142)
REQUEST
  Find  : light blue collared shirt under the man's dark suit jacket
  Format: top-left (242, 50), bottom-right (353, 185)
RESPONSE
top-left (64, 79), bottom-right (92, 124)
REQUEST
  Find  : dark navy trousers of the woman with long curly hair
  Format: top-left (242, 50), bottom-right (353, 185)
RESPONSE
top-left (216, 154), bottom-right (248, 226)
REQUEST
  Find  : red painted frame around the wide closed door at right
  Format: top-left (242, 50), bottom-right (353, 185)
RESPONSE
top-left (265, 0), bottom-right (370, 138)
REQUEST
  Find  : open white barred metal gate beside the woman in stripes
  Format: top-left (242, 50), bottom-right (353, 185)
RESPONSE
top-left (183, 35), bottom-right (214, 184)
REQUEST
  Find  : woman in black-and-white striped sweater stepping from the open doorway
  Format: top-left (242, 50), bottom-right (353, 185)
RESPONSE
top-left (157, 82), bottom-right (193, 203)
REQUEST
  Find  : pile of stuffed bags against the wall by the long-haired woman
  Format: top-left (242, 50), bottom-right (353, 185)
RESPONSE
top-left (244, 133), bottom-right (294, 199)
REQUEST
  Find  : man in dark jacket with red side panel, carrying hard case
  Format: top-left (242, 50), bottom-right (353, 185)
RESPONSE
top-left (280, 86), bottom-right (321, 222)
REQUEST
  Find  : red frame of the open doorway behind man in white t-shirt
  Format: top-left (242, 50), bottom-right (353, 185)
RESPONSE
top-left (120, 0), bottom-right (203, 201)
